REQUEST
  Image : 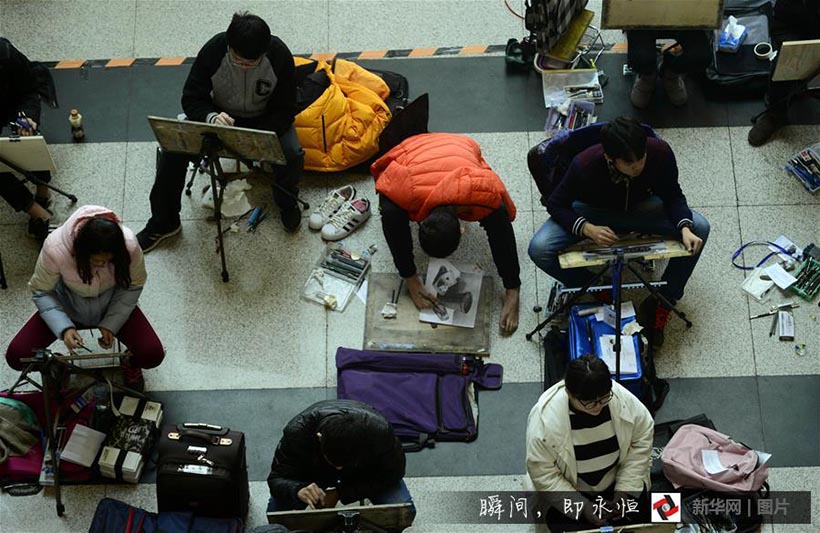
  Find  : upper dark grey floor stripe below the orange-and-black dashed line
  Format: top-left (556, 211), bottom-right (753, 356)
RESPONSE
top-left (33, 53), bottom-right (820, 143)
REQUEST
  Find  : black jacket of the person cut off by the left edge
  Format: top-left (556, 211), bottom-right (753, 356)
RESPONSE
top-left (0, 37), bottom-right (40, 124)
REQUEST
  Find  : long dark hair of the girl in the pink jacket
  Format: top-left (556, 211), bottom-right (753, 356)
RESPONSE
top-left (74, 218), bottom-right (131, 289)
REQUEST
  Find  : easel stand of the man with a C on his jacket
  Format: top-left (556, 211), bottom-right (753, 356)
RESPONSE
top-left (185, 133), bottom-right (310, 283)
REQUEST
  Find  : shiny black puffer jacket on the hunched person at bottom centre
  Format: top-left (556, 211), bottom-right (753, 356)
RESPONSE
top-left (268, 400), bottom-right (405, 507)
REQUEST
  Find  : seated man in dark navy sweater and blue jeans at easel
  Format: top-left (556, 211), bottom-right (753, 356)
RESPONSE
top-left (529, 117), bottom-right (710, 347)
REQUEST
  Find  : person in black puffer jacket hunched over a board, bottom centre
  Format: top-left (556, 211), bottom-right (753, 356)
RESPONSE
top-left (268, 400), bottom-right (415, 528)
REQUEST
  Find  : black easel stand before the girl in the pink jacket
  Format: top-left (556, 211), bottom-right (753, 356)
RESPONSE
top-left (8, 349), bottom-right (145, 516)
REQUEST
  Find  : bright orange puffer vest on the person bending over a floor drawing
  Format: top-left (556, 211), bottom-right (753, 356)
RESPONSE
top-left (370, 133), bottom-right (515, 222)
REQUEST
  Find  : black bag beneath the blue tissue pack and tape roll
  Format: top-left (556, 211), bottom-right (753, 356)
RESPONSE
top-left (703, 0), bottom-right (773, 100)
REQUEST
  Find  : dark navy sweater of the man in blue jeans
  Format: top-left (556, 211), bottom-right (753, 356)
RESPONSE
top-left (547, 137), bottom-right (692, 235)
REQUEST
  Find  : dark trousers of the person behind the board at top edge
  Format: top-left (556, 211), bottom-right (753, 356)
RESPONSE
top-left (626, 30), bottom-right (712, 74)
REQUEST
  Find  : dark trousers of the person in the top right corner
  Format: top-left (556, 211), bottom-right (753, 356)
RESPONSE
top-left (766, 0), bottom-right (820, 112)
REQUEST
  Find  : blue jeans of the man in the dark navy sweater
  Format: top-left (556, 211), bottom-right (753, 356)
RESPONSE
top-left (529, 196), bottom-right (709, 303)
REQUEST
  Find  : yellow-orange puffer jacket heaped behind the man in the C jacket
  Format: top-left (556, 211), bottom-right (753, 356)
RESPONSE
top-left (294, 57), bottom-right (391, 172)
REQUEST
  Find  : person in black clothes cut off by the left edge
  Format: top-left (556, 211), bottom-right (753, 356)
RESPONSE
top-left (0, 37), bottom-right (51, 243)
